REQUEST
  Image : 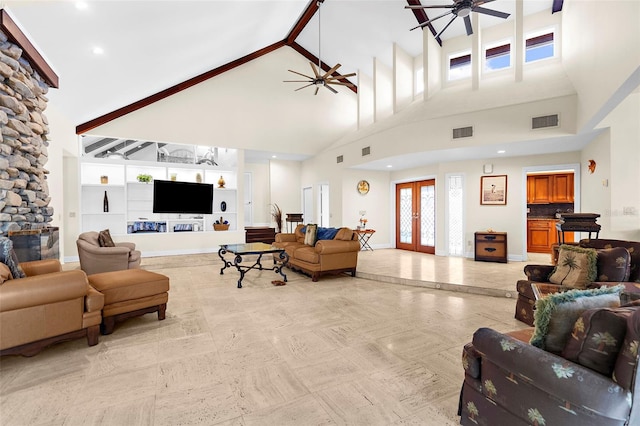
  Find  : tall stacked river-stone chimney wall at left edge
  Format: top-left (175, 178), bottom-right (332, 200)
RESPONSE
top-left (0, 31), bottom-right (53, 235)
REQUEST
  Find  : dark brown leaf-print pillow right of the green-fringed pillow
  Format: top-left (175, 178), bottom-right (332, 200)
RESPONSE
top-left (562, 308), bottom-right (635, 377)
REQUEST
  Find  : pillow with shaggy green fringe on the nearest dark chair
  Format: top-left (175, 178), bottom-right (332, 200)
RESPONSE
top-left (530, 285), bottom-right (624, 353)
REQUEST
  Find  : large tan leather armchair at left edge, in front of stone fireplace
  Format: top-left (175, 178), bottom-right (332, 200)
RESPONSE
top-left (0, 259), bottom-right (104, 356)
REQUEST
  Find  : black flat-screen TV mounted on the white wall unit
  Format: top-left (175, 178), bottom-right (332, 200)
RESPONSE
top-left (153, 180), bottom-right (213, 214)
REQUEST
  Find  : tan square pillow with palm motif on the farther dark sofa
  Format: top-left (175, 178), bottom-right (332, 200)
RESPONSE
top-left (549, 244), bottom-right (597, 288)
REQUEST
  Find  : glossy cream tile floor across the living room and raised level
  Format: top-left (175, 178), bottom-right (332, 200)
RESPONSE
top-left (0, 250), bottom-right (540, 426)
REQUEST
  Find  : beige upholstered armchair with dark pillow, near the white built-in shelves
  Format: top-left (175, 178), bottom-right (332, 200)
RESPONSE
top-left (76, 231), bottom-right (140, 275)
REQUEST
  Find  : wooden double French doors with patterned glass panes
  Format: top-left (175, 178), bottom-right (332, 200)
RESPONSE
top-left (396, 179), bottom-right (436, 254)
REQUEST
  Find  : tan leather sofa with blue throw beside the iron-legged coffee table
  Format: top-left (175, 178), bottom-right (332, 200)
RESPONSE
top-left (273, 224), bottom-right (360, 282)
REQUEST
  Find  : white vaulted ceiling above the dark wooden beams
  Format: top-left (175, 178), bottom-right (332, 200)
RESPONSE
top-left (4, 0), bottom-right (552, 166)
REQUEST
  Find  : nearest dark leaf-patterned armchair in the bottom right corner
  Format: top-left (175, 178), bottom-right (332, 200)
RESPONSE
top-left (458, 306), bottom-right (640, 426)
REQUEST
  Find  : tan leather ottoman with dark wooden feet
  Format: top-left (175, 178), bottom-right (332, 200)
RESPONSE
top-left (88, 269), bottom-right (169, 334)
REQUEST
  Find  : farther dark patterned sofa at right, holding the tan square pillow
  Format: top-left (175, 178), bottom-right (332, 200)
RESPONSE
top-left (515, 239), bottom-right (640, 325)
